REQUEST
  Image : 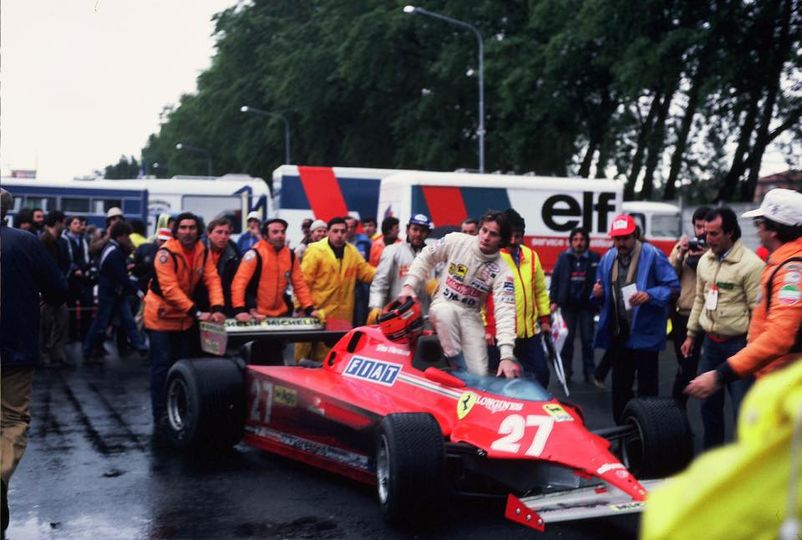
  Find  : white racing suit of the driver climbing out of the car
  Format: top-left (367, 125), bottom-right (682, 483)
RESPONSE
top-left (404, 233), bottom-right (515, 375)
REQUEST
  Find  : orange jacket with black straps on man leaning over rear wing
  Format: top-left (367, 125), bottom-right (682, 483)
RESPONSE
top-left (231, 240), bottom-right (314, 317)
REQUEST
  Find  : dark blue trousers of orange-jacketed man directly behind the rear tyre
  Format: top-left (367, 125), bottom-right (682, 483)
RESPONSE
top-left (148, 330), bottom-right (196, 422)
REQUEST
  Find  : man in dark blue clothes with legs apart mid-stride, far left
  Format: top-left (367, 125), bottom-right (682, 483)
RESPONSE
top-left (83, 221), bottom-right (148, 364)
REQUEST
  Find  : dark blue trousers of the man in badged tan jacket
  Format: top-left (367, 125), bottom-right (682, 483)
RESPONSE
top-left (699, 336), bottom-right (754, 450)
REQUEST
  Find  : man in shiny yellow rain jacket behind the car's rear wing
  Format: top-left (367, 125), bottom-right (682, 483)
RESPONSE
top-left (295, 217), bottom-right (376, 361)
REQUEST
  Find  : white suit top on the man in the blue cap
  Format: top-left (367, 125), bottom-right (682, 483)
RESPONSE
top-left (368, 242), bottom-right (434, 315)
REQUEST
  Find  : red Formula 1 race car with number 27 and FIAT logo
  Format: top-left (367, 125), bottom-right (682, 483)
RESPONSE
top-left (166, 304), bottom-right (693, 530)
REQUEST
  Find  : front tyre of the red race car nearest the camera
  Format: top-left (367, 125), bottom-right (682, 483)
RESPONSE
top-left (376, 413), bottom-right (445, 528)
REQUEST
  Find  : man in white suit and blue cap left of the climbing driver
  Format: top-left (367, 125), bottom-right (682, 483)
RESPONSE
top-left (368, 214), bottom-right (433, 324)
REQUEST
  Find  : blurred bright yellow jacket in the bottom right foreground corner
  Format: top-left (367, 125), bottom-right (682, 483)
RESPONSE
top-left (641, 356), bottom-right (802, 540)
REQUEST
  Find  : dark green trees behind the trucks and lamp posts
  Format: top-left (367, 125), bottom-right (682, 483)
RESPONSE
top-left (122, 0), bottom-right (802, 201)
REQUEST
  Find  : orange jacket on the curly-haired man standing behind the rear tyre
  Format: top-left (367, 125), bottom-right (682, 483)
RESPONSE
top-left (145, 238), bottom-right (224, 332)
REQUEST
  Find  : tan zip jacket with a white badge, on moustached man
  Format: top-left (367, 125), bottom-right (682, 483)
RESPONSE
top-left (688, 240), bottom-right (764, 338)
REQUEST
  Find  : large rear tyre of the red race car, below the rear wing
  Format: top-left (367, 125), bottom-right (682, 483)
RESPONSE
top-left (166, 358), bottom-right (245, 449)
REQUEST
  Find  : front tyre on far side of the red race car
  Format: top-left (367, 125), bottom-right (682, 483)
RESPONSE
top-left (621, 397), bottom-right (693, 478)
